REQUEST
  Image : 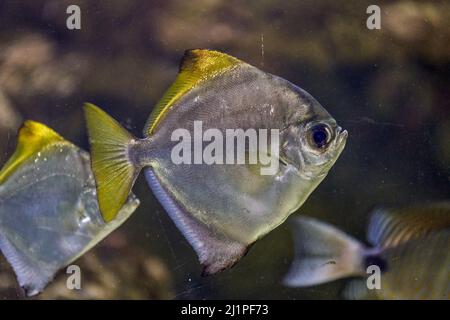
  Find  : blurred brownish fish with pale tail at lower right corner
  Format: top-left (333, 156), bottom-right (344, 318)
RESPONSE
top-left (284, 202), bottom-right (450, 299)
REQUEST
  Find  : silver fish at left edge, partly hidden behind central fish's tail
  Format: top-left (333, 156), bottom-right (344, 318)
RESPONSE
top-left (0, 121), bottom-right (139, 296)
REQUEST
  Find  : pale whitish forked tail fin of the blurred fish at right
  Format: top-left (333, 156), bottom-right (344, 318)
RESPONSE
top-left (284, 216), bottom-right (366, 287)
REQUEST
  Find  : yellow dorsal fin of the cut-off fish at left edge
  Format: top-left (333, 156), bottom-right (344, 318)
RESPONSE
top-left (0, 120), bottom-right (69, 184)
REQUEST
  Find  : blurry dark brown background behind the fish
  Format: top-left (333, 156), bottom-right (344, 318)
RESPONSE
top-left (0, 0), bottom-right (450, 299)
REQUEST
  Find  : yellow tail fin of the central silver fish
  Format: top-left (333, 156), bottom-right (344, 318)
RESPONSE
top-left (84, 103), bottom-right (140, 222)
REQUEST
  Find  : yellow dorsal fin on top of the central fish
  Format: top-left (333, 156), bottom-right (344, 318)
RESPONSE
top-left (144, 49), bottom-right (244, 136)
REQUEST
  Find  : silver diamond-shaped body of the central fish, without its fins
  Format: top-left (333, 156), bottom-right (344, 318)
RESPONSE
top-left (144, 65), bottom-right (345, 244)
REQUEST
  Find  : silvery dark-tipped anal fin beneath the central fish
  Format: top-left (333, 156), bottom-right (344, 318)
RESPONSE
top-left (145, 168), bottom-right (249, 276)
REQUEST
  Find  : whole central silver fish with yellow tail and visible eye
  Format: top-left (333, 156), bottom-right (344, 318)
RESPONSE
top-left (85, 49), bottom-right (347, 275)
